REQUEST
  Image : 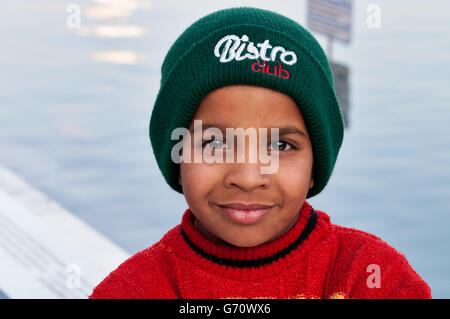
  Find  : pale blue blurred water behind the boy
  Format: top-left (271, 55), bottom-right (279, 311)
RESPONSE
top-left (0, 0), bottom-right (450, 298)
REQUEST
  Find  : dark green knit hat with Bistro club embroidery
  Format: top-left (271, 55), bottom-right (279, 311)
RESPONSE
top-left (150, 7), bottom-right (344, 198)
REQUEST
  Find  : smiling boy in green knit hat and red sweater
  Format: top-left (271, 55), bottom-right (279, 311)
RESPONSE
top-left (90, 8), bottom-right (431, 298)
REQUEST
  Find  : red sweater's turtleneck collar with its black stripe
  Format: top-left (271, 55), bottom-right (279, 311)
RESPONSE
top-left (180, 201), bottom-right (318, 268)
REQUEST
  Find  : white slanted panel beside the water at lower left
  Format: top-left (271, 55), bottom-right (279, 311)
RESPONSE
top-left (0, 165), bottom-right (129, 299)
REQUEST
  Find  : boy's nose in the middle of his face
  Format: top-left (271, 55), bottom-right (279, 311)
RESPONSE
top-left (224, 163), bottom-right (271, 192)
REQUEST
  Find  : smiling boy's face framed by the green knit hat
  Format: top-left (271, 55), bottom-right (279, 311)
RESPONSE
top-left (179, 85), bottom-right (314, 247)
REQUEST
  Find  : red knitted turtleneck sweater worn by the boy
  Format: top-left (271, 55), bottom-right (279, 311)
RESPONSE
top-left (90, 201), bottom-right (431, 299)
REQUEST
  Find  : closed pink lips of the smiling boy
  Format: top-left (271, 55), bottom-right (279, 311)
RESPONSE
top-left (217, 203), bottom-right (276, 225)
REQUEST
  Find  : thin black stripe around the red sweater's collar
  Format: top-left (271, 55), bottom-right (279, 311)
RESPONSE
top-left (180, 207), bottom-right (318, 268)
